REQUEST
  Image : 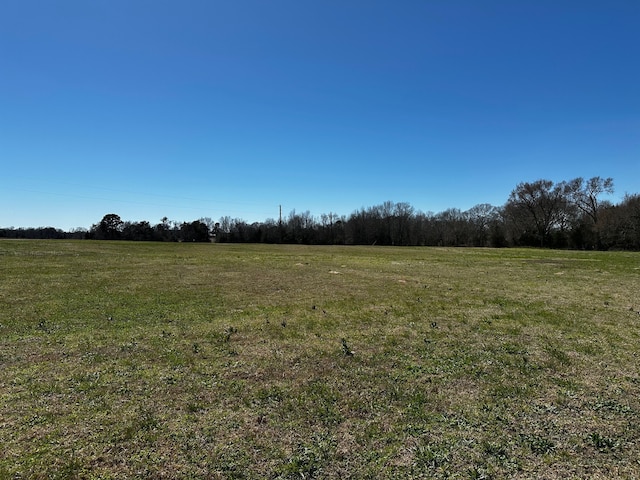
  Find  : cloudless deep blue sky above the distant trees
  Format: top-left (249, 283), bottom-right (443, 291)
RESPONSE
top-left (0, 0), bottom-right (640, 229)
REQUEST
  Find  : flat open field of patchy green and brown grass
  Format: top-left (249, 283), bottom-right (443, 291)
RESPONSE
top-left (0, 241), bottom-right (640, 479)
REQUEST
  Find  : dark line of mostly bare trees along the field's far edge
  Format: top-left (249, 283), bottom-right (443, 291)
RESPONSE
top-left (0, 177), bottom-right (640, 250)
